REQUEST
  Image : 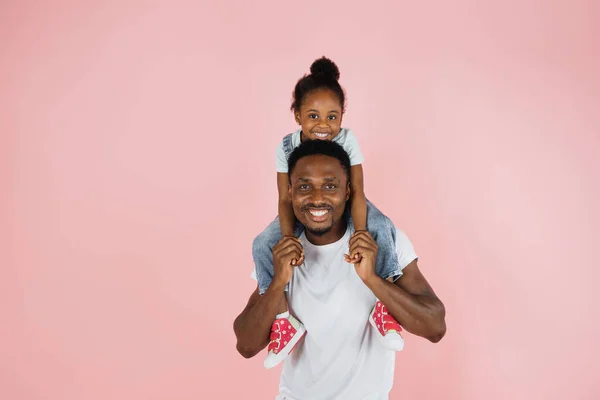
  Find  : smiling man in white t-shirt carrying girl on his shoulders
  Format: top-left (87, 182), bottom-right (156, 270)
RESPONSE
top-left (234, 140), bottom-right (446, 400)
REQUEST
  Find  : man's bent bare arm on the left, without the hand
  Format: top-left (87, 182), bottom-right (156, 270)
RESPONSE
top-left (233, 282), bottom-right (285, 358)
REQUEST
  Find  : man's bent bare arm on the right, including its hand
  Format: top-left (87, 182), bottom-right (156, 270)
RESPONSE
top-left (350, 232), bottom-right (446, 343)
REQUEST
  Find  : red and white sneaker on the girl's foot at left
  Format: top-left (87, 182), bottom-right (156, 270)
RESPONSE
top-left (264, 313), bottom-right (306, 369)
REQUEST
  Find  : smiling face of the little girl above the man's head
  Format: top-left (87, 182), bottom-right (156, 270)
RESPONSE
top-left (295, 89), bottom-right (342, 141)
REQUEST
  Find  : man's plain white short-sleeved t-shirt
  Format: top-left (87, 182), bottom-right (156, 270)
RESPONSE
top-left (252, 229), bottom-right (417, 400)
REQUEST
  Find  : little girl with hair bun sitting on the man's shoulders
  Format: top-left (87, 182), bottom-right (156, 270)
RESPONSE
top-left (252, 57), bottom-right (404, 369)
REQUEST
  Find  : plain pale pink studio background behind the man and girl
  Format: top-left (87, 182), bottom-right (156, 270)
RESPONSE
top-left (0, 0), bottom-right (600, 400)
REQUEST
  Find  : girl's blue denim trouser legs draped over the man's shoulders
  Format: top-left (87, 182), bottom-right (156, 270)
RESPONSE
top-left (252, 200), bottom-right (401, 294)
